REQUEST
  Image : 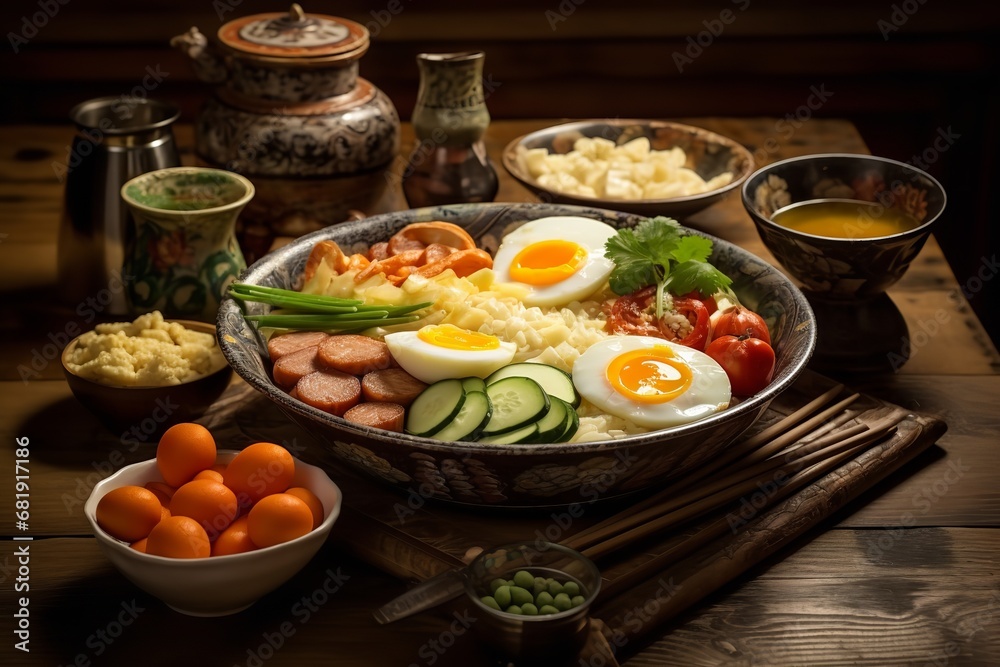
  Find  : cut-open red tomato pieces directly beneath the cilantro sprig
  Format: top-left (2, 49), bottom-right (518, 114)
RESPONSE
top-left (607, 285), bottom-right (709, 351)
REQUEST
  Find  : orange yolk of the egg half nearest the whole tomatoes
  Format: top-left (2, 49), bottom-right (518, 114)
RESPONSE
top-left (607, 346), bottom-right (693, 403)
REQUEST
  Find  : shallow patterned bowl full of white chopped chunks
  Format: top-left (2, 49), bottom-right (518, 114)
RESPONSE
top-left (503, 119), bottom-right (754, 217)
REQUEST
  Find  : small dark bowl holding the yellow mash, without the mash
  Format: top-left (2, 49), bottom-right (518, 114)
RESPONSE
top-left (61, 320), bottom-right (233, 439)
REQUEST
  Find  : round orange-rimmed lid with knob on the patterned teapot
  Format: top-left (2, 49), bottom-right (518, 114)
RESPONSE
top-left (218, 3), bottom-right (368, 58)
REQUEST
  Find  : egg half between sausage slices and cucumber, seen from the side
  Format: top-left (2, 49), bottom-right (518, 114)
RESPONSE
top-left (385, 324), bottom-right (517, 384)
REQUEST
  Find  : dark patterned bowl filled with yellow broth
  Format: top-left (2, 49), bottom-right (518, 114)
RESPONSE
top-left (742, 153), bottom-right (947, 301)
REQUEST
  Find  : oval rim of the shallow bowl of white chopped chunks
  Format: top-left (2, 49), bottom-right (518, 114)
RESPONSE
top-left (501, 118), bottom-right (755, 206)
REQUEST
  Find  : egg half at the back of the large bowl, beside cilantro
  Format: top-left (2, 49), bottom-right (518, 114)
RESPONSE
top-left (493, 216), bottom-right (617, 306)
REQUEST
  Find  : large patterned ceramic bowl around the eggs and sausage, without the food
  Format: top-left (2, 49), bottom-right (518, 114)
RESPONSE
top-left (217, 203), bottom-right (816, 507)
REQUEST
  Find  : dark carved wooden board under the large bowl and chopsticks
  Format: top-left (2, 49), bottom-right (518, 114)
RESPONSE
top-left (206, 371), bottom-right (947, 665)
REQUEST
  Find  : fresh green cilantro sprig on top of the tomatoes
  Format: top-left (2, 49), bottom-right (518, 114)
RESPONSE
top-left (604, 216), bottom-right (733, 318)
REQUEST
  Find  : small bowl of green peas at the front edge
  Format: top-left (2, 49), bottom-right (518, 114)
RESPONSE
top-left (465, 540), bottom-right (601, 660)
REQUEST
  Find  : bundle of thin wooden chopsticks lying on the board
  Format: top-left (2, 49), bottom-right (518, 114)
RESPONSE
top-left (563, 385), bottom-right (899, 572)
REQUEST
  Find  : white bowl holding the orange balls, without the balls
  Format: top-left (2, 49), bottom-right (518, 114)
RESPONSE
top-left (84, 450), bottom-right (342, 616)
